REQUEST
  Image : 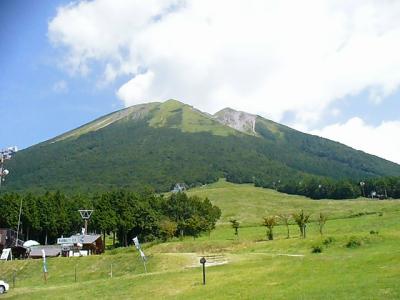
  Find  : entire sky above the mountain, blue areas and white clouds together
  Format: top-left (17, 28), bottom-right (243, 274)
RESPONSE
top-left (0, 0), bottom-right (400, 163)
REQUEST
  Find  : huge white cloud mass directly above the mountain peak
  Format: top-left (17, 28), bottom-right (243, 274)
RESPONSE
top-left (49, 0), bottom-right (400, 126)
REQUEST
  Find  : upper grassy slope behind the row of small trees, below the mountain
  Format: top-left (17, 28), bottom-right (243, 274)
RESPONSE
top-left (189, 179), bottom-right (400, 226)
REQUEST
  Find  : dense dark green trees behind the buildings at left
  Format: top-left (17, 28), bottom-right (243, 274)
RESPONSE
top-left (0, 190), bottom-right (221, 246)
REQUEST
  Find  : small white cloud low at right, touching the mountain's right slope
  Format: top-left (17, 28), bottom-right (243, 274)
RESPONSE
top-left (310, 117), bottom-right (400, 164)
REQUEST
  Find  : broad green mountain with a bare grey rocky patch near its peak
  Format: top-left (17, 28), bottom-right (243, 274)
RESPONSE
top-left (3, 100), bottom-right (400, 191)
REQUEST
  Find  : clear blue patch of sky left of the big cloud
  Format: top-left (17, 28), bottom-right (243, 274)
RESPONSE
top-left (0, 0), bottom-right (123, 148)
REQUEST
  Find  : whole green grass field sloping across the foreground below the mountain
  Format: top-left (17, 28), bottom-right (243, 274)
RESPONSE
top-left (0, 181), bottom-right (400, 299)
